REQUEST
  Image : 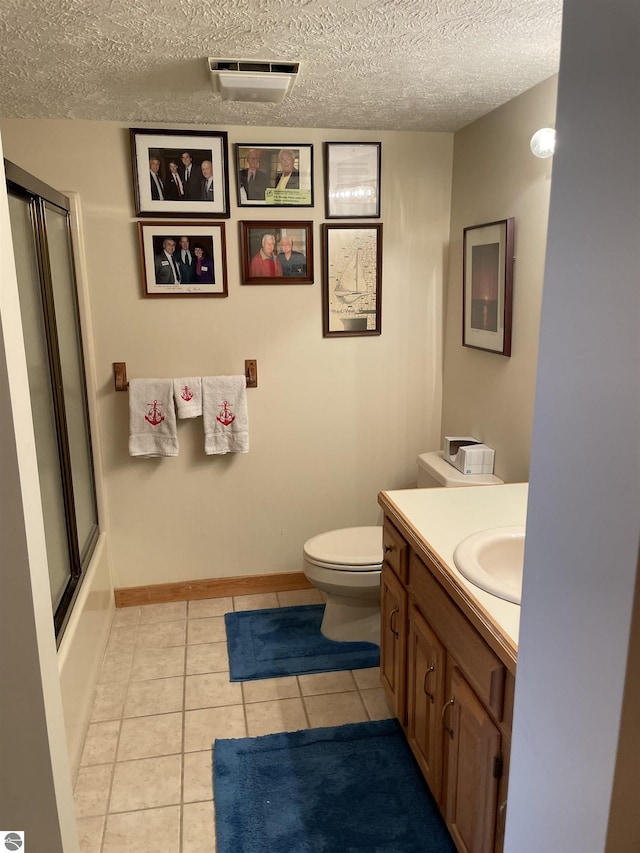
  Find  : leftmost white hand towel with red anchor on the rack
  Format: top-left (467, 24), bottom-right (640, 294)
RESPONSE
top-left (129, 379), bottom-right (178, 456)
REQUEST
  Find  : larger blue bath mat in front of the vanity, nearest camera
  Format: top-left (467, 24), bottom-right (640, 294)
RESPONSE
top-left (213, 720), bottom-right (455, 853)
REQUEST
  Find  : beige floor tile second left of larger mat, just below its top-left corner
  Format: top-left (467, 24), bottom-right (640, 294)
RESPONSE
top-left (109, 755), bottom-right (182, 814)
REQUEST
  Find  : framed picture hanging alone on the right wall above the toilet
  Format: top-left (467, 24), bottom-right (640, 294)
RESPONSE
top-left (462, 217), bottom-right (515, 356)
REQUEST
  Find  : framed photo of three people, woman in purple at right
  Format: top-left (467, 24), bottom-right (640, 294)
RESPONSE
top-left (138, 221), bottom-right (228, 296)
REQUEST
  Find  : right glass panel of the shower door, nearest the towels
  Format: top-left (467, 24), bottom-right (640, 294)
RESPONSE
top-left (45, 203), bottom-right (98, 562)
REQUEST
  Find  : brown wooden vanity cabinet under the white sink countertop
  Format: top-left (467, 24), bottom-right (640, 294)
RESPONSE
top-left (380, 519), bottom-right (513, 853)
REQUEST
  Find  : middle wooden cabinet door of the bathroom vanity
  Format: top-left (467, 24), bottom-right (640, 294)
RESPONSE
top-left (407, 607), bottom-right (445, 801)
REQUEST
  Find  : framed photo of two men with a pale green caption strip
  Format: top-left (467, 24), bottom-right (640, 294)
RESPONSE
top-left (236, 142), bottom-right (313, 207)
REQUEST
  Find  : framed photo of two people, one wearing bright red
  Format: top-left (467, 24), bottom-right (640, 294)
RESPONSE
top-left (240, 222), bottom-right (313, 284)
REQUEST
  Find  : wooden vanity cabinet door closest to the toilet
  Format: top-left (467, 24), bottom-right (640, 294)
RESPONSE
top-left (380, 563), bottom-right (407, 725)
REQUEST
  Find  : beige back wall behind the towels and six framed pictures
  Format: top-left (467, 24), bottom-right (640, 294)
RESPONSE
top-left (1, 120), bottom-right (452, 587)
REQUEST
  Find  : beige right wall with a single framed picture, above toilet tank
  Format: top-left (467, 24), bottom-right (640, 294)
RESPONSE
top-left (442, 77), bottom-right (557, 482)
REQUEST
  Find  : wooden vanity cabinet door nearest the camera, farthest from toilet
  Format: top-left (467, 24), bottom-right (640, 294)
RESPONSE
top-left (442, 666), bottom-right (502, 853)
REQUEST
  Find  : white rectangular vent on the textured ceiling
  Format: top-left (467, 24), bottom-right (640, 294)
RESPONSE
top-left (207, 57), bottom-right (300, 104)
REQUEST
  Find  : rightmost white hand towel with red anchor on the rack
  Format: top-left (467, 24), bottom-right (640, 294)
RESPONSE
top-left (202, 376), bottom-right (249, 456)
